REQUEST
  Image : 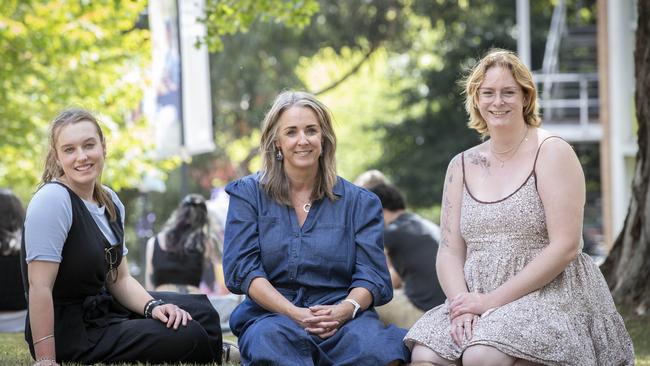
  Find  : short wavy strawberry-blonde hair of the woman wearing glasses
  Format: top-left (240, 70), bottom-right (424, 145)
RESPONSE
top-left (461, 48), bottom-right (542, 137)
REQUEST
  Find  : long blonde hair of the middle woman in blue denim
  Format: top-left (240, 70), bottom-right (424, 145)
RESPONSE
top-left (260, 91), bottom-right (336, 206)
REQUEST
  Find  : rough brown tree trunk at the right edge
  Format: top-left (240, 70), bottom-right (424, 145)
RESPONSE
top-left (602, 0), bottom-right (650, 313)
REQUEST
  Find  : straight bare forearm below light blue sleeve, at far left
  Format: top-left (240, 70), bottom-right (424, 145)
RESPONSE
top-left (27, 260), bottom-right (63, 360)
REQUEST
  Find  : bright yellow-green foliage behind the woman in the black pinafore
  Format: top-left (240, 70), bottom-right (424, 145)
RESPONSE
top-left (0, 0), bottom-right (173, 199)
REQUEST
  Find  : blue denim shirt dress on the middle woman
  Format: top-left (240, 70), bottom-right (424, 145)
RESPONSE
top-left (223, 174), bottom-right (409, 365)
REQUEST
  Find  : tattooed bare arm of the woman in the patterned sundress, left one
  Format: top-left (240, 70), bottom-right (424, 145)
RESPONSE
top-left (436, 155), bottom-right (468, 299)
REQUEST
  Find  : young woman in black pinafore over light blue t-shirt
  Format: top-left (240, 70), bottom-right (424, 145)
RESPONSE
top-left (23, 110), bottom-right (222, 366)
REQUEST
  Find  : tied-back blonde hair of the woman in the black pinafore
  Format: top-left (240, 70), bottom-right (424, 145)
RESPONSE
top-left (39, 108), bottom-right (117, 221)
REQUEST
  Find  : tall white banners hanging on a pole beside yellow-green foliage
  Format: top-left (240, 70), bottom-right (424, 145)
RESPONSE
top-left (145, 0), bottom-right (215, 158)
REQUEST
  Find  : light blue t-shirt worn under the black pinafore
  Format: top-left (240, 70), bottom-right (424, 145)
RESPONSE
top-left (24, 184), bottom-right (128, 263)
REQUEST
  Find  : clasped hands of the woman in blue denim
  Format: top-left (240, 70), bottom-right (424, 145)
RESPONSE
top-left (290, 303), bottom-right (354, 339)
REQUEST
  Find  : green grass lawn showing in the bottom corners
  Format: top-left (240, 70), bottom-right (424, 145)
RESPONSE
top-left (0, 308), bottom-right (650, 366)
